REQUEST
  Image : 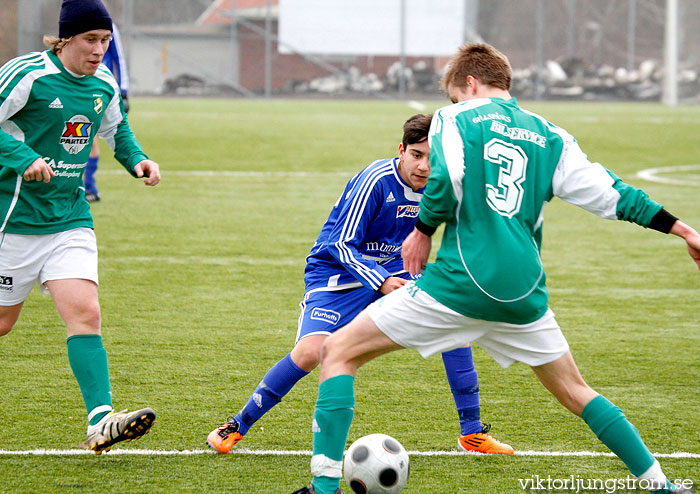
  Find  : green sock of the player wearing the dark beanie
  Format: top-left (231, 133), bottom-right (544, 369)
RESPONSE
top-left (66, 334), bottom-right (112, 425)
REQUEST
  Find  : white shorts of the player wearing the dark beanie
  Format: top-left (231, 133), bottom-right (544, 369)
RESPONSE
top-left (0, 227), bottom-right (98, 306)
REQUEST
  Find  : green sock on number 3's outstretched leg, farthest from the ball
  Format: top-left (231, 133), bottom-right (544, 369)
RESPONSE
top-left (581, 395), bottom-right (654, 477)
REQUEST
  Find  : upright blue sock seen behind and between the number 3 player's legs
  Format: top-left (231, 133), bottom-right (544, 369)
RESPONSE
top-left (442, 347), bottom-right (482, 435)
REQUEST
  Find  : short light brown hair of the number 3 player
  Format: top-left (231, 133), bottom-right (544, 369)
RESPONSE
top-left (441, 43), bottom-right (513, 91)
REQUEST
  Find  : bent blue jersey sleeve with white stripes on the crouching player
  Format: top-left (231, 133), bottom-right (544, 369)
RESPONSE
top-left (327, 174), bottom-right (391, 290)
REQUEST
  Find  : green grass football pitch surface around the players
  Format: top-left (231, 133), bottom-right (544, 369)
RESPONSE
top-left (0, 99), bottom-right (700, 494)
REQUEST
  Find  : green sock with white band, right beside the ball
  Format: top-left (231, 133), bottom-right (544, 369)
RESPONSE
top-left (311, 374), bottom-right (355, 494)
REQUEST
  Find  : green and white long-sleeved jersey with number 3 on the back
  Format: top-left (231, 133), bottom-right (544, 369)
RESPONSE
top-left (417, 98), bottom-right (662, 324)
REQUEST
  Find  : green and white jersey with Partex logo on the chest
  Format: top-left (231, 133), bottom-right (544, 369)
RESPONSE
top-left (0, 51), bottom-right (147, 235)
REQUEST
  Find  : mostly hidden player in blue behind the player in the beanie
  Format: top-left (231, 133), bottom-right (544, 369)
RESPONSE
top-left (84, 24), bottom-right (129, 202)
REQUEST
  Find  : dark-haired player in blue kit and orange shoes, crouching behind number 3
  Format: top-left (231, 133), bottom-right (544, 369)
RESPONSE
top-left (207, 114), bottom-right (513, 454)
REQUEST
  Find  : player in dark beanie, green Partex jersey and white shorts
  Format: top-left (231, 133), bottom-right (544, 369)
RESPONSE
top-left (0, 0), bottom-right (160, 454)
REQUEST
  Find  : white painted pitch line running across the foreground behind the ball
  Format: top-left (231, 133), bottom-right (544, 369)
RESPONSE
top-left (0, 449), bottom-right (700, 459)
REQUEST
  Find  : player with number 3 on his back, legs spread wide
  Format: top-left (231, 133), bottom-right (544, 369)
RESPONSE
top-left (297, 44), bottom-right (700, 494)
